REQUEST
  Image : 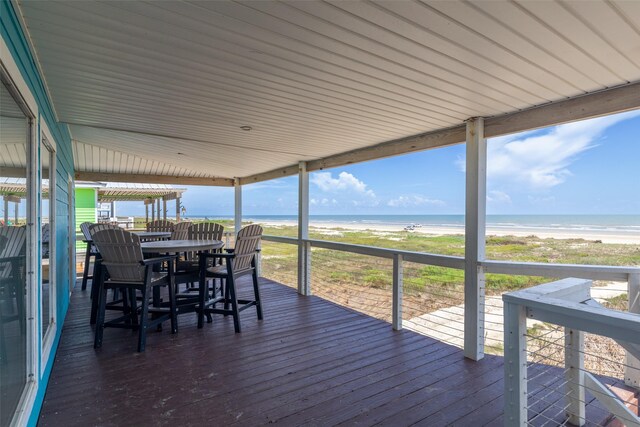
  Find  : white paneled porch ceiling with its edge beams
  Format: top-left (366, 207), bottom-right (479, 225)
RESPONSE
top-left (19, 0), bottom-right (640, 185)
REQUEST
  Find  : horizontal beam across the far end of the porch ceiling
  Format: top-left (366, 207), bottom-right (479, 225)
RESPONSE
top-left (74, 169), bottom-right (234, 187)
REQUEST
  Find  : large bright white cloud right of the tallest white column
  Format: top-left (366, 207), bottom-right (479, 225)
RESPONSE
top-left (455, 110), bottom-right (640, 190)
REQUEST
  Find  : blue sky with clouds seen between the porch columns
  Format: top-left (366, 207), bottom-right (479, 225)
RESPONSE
top-left (118, 110), bottom-right (640, 217)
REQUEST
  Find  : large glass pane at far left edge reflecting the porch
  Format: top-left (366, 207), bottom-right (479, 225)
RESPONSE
top-left (0, 83), bottom-right (30, 425)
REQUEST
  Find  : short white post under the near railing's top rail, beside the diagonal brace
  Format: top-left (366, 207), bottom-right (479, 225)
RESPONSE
top-left (564, 328), bottom-right (586, 426)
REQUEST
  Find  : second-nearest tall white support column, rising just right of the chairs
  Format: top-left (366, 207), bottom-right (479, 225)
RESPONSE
top-left (298, 162), bottom-right (311, 295)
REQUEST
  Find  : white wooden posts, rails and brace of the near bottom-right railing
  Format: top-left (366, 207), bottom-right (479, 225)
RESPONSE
top-left (503, 280), bottom-right (640, 426)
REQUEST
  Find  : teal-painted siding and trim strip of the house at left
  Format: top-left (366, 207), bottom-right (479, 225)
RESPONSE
top-left (0, 0), bottom-right (75, 426)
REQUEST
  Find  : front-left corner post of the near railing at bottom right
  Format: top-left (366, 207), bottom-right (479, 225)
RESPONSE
top-left (504, 302), bottom-right (527, 427)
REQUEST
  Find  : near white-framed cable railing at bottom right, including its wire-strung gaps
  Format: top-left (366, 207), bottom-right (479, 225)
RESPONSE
top-left (503, 280), bottom-right (640, 426)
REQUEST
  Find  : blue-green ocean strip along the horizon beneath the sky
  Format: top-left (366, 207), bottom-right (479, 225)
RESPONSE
top-left (184, 215), bottom-right (640, 233)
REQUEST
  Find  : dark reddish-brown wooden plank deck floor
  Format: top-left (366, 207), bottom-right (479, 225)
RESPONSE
top-left (39, 279), bottom-right (616, 426)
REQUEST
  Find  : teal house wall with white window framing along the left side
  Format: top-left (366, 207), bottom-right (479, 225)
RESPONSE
top-left (0, 0), bottom-right (75, 425)
